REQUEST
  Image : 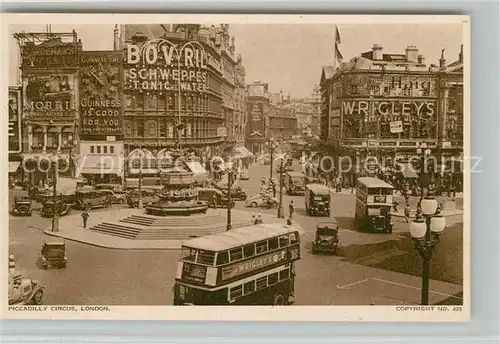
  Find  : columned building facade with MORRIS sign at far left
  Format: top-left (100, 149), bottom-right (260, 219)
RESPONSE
top-left (14, 31), bottom-right (82, 184)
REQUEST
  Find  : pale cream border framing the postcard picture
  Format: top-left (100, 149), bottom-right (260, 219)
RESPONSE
top-left (0, 13), bottom-right (471, 322)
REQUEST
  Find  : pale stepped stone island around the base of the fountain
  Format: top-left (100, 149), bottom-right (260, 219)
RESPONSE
top-left (44, 209), bottom-right (292, 250)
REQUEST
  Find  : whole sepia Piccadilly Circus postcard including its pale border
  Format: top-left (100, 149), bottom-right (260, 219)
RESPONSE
top-left (1, 14), bottom-right (468, 321)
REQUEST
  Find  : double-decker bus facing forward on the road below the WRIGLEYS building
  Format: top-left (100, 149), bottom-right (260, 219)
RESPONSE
top-left (355, 177), bottom-right (394, 233)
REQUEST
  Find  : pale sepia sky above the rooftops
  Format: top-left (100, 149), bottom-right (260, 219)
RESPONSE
top-left (9, 24), bottom-right (463, 97)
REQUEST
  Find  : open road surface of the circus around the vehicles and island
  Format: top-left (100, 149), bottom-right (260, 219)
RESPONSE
top-left (9, 160), bottom-right (463, 305)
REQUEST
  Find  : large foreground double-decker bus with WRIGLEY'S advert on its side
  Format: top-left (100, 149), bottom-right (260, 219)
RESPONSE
top-left (174, 224), bottom-right (301, 305)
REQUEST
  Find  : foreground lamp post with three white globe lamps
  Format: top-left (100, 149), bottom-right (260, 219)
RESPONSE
top-left (410, 194), bottom-right (446, 305)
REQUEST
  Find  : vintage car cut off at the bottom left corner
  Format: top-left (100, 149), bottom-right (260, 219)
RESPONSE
top-left (8, 269), bottom-right (44, 305)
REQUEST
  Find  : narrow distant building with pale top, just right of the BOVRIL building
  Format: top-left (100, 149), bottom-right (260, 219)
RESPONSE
top-left (245, 81), bottom-right (270, 153)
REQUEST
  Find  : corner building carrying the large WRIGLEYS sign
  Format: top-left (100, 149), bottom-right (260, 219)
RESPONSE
top-left (320, 44), bottom-right (463, 184)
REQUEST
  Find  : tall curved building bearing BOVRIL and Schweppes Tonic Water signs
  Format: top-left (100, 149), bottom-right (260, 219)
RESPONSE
top-left (122, 25), bottom-right (227, 175)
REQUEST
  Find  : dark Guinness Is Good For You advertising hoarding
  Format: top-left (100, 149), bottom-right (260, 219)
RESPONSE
top-left (79, 51), bottom-right (123, 137)
